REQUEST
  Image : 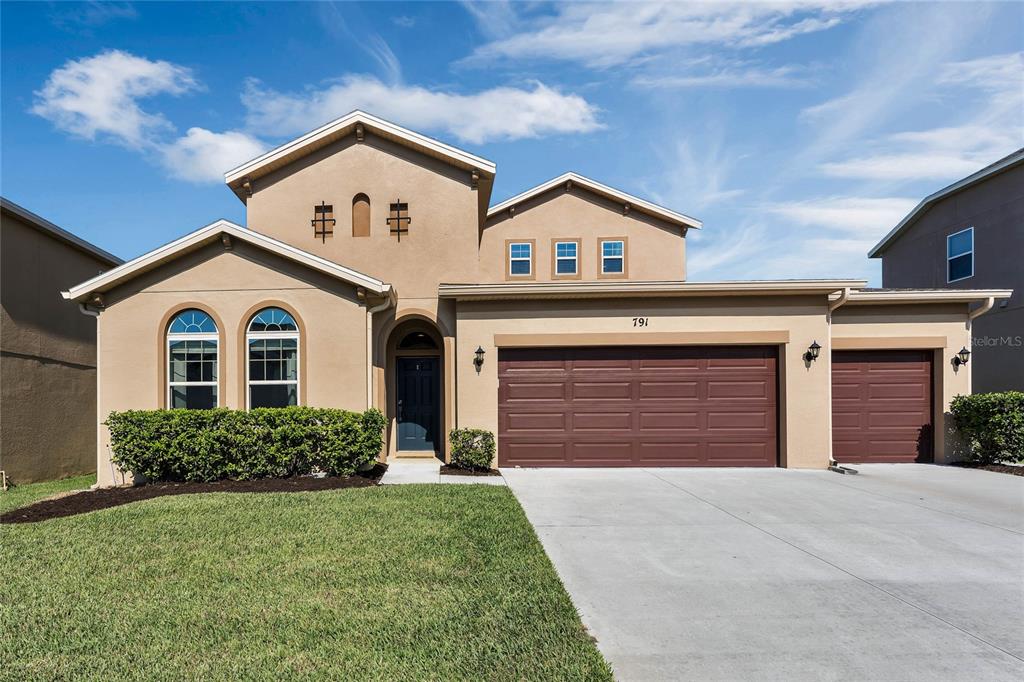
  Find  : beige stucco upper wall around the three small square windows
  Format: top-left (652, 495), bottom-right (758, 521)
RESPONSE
top-left (479, 187), bottom-right (686, 283)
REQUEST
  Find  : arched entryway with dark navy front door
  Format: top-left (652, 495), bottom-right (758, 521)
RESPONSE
top-left (387, 318), bottom-right (444, 457)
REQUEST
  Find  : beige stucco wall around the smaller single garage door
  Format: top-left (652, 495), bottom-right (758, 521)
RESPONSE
top-left (822, 303), bottom-right (974, 464)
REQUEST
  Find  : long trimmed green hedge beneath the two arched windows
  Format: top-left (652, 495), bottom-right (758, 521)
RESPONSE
top-left (105, 407), bottom-right (384, 481)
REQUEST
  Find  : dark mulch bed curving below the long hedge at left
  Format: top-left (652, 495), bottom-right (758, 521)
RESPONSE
top-left (0, 464), bottom-right (387, 523)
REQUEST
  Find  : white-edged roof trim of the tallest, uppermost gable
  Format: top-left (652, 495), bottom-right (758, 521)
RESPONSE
top-left (224, 110), bottom-right (497, 202)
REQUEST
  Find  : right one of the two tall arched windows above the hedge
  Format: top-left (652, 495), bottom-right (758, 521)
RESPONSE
top-left (246, 308), bottom-right (299, 408)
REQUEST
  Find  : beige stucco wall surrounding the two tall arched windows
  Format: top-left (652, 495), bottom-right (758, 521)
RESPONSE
top-left (96, 244), bottom-right (369, 485)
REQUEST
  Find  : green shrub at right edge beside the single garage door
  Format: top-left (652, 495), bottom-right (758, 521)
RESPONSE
top-left (950, 391), bottom-right (1024, 464)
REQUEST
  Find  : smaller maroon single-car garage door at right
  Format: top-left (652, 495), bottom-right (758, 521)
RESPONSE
top-left (833, 350), bottom-right (932, 463)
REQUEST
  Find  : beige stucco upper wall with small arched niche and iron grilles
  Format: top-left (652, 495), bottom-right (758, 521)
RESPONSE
top-left (246, 133), bottom-right (479, 296)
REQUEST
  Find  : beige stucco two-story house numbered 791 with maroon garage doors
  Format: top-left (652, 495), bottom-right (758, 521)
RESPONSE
top-left (65, 112), bottom-right (1010, 483)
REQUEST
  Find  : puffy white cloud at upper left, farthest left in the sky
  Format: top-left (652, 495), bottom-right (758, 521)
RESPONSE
top-left (31, 50), bottom-right (199, 147)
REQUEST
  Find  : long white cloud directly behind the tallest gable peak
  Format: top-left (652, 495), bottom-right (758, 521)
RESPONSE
top-left (242, 75), bottom-right (601, 144)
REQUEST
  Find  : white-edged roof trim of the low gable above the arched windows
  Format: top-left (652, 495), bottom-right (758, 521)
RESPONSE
top-left (60, 220), bottom-right (391, 302)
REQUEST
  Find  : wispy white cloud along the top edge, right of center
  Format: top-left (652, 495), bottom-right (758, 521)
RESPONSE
top-left (467, 1), bottom-right (865, 68)
